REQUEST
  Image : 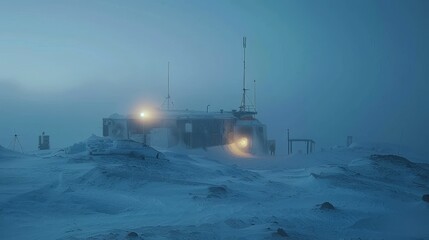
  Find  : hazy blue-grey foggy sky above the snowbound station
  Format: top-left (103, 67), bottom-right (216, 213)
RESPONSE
top-left (0, 0), bottom-right (429, 156)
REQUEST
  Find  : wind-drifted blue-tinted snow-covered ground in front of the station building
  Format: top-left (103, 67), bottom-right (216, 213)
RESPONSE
top-left (0, 142), bottom-right (429, 239)
